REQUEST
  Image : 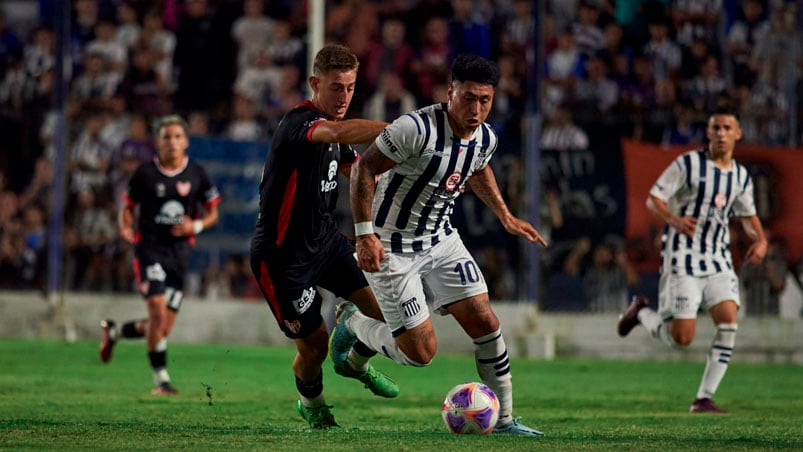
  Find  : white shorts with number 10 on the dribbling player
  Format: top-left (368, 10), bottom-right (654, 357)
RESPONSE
top-left (365, 232), bottom-right (488, 337)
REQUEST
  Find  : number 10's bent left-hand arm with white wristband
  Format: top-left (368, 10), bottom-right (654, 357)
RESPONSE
top-left (349, 144), bottom-right (396, 272)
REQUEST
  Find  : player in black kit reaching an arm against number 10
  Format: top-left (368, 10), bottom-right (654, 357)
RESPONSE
top-left (251, 45), bottom-right (399, 429)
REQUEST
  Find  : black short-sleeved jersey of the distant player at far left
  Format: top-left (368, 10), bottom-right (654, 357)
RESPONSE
top-left (123, 158), bottom-right (220, 245)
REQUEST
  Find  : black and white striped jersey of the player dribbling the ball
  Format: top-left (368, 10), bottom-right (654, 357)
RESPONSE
top-left (372, 104), bottom-right (497, 253)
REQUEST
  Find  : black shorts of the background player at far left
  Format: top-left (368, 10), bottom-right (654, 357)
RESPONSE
top-left (134, 243), bottom-right (190, 312)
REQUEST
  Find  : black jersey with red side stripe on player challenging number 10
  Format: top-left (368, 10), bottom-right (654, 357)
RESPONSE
top-left (251, 101), bottom-right (359, 267)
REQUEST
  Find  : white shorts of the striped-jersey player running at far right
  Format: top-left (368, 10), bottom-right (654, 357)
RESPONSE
top-left (658, 271), bottom-right (741, 319)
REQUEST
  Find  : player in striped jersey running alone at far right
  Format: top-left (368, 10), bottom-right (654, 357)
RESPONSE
top-left (617, 110), bottom-right (767, 413)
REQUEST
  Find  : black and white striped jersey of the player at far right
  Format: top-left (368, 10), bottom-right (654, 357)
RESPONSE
top-left (650, 149), bottom-right (756, 276)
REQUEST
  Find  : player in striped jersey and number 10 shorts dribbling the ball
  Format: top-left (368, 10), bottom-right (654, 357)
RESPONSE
top-left (330, 55), bottom-right (546, 436)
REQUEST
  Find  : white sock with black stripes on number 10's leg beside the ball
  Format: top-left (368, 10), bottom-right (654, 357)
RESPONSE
top-left (474, 329), bottom-right (513, 425)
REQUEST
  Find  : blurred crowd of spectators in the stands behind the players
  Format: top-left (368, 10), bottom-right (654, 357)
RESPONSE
top-left (0, 0), bottom-right (803, 313)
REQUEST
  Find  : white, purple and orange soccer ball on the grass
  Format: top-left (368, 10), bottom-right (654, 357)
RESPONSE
top-left (441, 383), bottom-right (499, 435)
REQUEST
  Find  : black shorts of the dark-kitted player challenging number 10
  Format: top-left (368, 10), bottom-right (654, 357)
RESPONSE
top-left (251, 235), bottom-right (368, 339)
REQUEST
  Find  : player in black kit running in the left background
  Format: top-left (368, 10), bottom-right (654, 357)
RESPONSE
top-left (100, 116), bottom-right (220, 395)
